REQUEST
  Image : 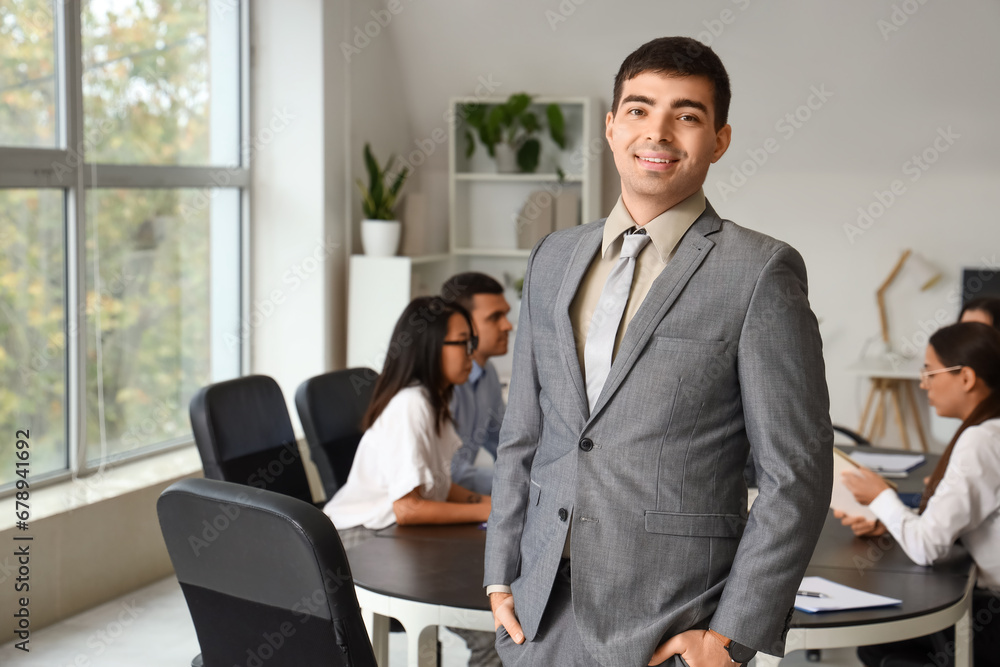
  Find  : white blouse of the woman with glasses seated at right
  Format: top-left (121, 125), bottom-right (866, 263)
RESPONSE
top-left (870, 419), bottom-right (1000, 591)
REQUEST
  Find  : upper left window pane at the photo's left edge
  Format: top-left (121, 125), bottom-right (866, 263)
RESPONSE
top-left (0, 0), bottom-right (58, 148)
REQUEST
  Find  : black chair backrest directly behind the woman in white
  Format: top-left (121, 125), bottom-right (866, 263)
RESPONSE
top-left (295, 368), bottom-right (378, 499)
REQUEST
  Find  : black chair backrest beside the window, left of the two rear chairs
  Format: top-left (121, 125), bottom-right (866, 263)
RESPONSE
top-left (190, 375), bottom-right (312, 502)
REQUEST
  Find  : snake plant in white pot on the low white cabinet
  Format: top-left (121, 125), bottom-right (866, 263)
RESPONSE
top-left (357, 143), bottom-right (409, 257)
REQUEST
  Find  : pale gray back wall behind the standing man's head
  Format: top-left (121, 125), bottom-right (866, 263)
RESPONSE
top-left (376, 0), bottom-right (1000, 442)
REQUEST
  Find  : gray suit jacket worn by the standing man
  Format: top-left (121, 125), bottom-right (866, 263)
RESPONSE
top-left (484, 206), bottom-right (833, 667)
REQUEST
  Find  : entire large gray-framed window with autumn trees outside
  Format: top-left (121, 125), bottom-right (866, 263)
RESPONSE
top-left (0, 0), bottom-right (249, 491)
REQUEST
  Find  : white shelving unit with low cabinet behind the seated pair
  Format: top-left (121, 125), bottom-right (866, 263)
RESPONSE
top-left (347, 97), bottom-right (607, 378)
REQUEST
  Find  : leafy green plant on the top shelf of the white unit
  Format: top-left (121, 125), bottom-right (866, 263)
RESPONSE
top-left (462, 93), bottom-right (566, 173)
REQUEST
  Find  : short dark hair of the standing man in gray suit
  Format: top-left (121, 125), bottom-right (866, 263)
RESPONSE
top-left (611, 37), bottom-right (732, 132)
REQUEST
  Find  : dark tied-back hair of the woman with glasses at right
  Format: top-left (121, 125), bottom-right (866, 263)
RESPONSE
top-left (920, 322), bottom-right (1000, 514)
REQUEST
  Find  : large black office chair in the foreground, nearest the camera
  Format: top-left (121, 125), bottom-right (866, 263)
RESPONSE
top-left (156, 479), bottom-right (375, 667)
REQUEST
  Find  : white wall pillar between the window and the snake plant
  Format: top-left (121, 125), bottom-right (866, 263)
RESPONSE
top-left (252, 0), bottom-right (349, 430)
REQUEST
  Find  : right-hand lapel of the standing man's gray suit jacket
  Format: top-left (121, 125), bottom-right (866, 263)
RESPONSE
top-left (577, 203), bottom-right (722, 420)
